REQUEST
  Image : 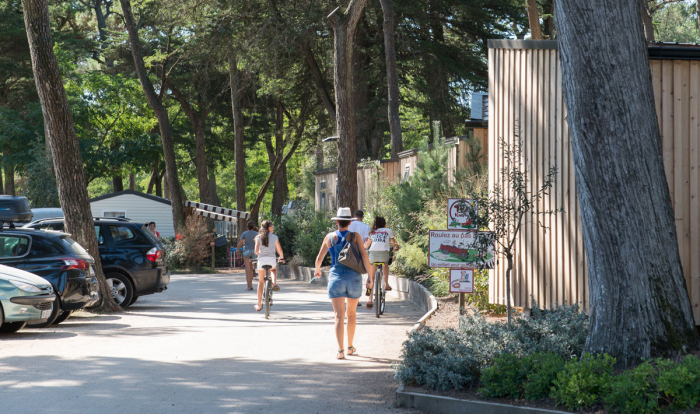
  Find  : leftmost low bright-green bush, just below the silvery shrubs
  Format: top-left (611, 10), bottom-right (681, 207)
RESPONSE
top-left (479, 354), bottom-right (527, 399)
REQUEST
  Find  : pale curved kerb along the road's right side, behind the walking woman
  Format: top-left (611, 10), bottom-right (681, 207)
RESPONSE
top-left (277, 264), bottom-right (437, 332)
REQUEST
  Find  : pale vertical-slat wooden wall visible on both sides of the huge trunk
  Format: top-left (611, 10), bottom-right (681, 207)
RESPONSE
top-left (488, 43), bottom-right (700, 324)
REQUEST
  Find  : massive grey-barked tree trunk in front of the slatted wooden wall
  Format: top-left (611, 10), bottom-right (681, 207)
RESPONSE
top-left (556, 0), bottom-right (700, 366)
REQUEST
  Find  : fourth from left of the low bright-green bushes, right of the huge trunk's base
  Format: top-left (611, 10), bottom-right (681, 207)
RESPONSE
top-left (603, 362), bottom-right (659, 414)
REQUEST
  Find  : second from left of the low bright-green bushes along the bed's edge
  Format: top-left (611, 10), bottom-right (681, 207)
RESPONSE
top-left (523, 352), bottom-right (564, 401)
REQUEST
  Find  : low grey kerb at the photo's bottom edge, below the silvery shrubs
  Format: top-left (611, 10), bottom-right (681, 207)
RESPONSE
top-left (396, 385), bottom-right (570, 414)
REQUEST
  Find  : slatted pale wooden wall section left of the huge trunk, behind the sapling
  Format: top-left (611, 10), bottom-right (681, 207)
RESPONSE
top-left (488, 44), bottom-right (589, 309)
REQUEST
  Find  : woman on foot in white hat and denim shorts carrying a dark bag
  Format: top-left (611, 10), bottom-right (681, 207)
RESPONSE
top-left (314, 207), bottom-right (373, 359)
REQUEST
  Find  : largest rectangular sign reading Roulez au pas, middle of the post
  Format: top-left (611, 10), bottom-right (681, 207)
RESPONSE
top-left (428, 230), bottom-right (496, 269)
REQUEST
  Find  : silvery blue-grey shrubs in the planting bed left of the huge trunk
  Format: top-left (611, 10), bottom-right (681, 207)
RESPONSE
top-left (395, 306), bottom-right (588, 390)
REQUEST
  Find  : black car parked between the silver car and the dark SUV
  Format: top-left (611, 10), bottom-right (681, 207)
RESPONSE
top-left (0, 228), bottom-right (100, 327)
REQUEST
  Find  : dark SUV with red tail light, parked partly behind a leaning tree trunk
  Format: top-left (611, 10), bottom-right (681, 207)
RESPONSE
top-left (23, 217), bottom-right (170, 308)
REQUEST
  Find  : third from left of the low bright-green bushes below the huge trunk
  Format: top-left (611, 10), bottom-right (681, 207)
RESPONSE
top-left (551, 353), bottom-right (616, 410)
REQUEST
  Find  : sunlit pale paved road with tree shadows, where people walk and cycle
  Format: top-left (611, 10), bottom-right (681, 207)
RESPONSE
top-left (0, 274), bottom-right (421, 414)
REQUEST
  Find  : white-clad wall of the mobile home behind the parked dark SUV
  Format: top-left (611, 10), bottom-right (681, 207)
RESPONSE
top-left (90, 194), bottom-right (175, 237)
